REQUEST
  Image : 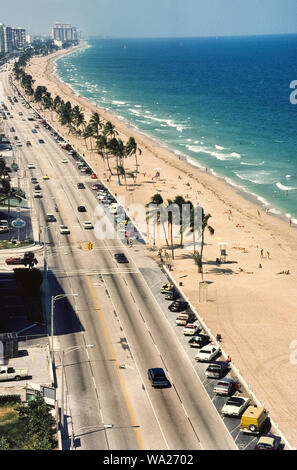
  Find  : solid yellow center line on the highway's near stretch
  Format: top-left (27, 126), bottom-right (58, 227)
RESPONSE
top-left (85, 276), bottom-right (145, 450)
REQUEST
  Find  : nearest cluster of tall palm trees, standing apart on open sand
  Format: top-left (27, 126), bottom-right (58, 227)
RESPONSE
top-left (146, 193), bottom-right (214, 277)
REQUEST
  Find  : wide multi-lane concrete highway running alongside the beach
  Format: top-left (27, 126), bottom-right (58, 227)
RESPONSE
top-left (1, 68), bottom-right (237, 450)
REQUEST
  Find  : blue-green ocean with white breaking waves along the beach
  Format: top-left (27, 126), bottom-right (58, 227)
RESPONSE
top-left (56, 35), bottom-right (297, 224)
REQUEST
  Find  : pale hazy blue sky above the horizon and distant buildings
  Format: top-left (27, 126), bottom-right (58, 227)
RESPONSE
top-left (0, 0), bottom-right (297, 37)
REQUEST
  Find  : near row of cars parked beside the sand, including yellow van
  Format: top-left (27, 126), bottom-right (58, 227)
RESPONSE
top-left (160, 283), bottom-right (284, 450)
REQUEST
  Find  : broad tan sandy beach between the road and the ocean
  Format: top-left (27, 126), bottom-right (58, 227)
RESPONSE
top-left (26, 42), bottom-right (297, 447)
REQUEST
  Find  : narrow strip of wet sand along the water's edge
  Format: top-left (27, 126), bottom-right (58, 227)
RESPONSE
top-left (52, 41), bottom-right (297, 229)
